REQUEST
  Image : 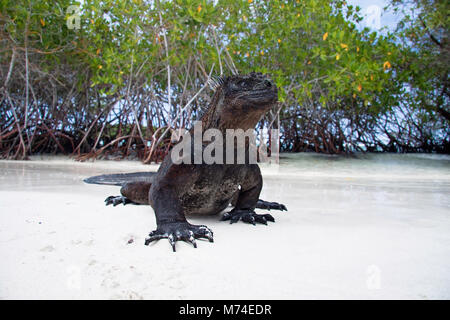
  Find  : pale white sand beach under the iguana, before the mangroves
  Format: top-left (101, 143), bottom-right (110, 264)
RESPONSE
top-left (0, 154), bottom-right (450, 299)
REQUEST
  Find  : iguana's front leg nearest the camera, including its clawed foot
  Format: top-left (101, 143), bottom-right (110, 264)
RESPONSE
top-left (145, 175), bottom-right (214, 252)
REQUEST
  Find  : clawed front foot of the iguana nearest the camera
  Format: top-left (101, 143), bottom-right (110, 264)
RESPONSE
top-left (145, 222), bottom-right (214, 252)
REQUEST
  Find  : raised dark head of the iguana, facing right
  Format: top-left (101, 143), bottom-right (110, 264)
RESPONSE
top-left (202, 72), bottom-right (278, 130)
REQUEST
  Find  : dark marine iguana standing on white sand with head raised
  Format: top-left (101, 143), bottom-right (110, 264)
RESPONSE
top-left (84, 73), bottom-right (287, 251)
